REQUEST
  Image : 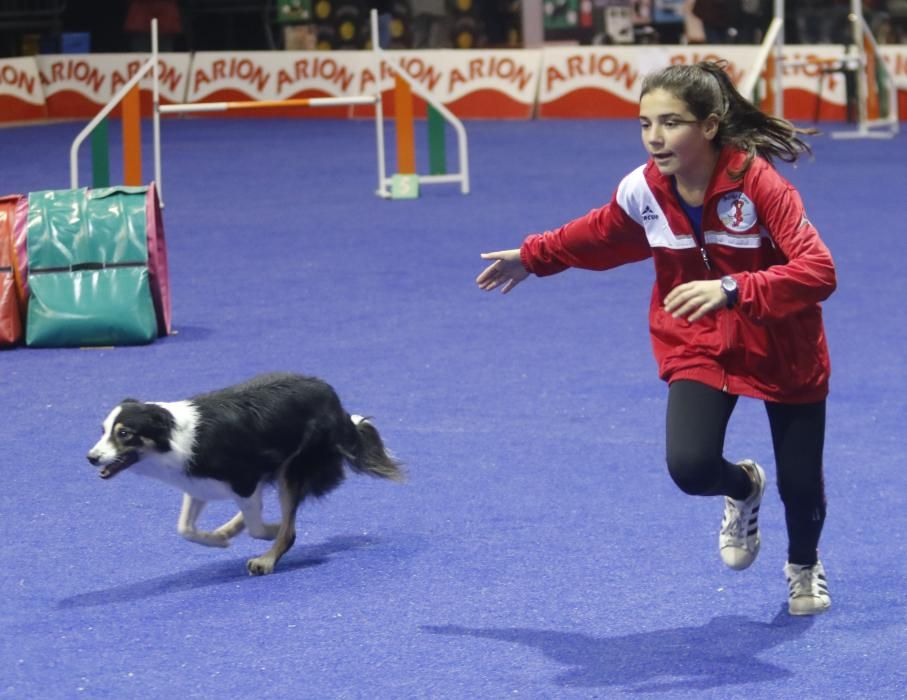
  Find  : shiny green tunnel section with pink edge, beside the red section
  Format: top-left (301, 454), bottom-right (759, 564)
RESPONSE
top-left (25, 186), bottom-right (170, 347)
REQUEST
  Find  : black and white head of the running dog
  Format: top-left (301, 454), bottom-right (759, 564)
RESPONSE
top-left (88, 399), bottom-right (174, 479)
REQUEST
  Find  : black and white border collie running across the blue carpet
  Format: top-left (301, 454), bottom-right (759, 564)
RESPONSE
top-left (88, 374), bottom-right (403, 576)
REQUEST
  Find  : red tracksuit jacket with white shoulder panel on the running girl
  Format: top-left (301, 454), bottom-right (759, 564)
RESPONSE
top-left (520, 147), bottom-right (836, 403)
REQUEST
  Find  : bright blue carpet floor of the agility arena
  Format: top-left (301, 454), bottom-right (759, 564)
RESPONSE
top-left (0, 120), bottom-right (907, 700)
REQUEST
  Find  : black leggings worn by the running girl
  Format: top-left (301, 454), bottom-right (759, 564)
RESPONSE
top-left (666, 380), bottom-right (825, 565)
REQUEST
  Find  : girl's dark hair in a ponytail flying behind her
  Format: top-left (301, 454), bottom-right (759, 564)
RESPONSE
top-left (640, 61), bottom-right (818, 179)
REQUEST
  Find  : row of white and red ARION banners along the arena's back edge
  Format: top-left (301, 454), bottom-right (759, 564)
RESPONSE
top-left (0, 45), bottom-right (907, 122)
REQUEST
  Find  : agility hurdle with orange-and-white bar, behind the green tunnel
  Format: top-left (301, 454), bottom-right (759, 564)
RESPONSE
top-left (70, 10), bottom-right (469, 206)
